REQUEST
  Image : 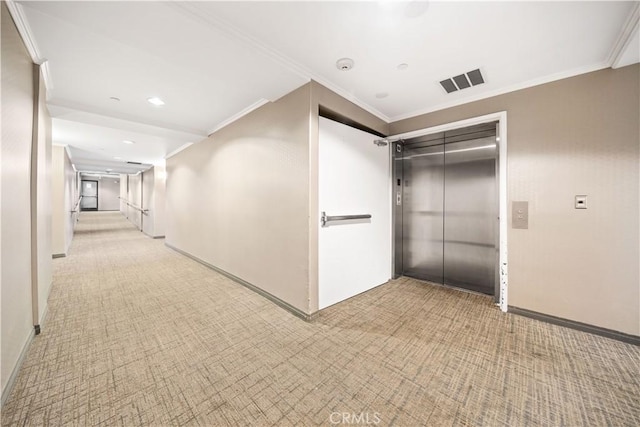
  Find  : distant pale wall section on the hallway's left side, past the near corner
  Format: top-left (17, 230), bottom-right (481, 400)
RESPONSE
top-left (51, 145), bottom-right (77, 256)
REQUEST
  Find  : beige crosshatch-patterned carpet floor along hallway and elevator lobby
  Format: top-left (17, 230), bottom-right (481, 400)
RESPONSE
top-left (2, 213), bottom-right (640, 426)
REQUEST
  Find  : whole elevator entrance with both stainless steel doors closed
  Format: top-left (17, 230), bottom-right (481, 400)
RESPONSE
top-left (392, 122), bottom-right (499, 299)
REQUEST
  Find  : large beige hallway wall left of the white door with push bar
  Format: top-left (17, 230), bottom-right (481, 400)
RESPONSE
top-left (165, 84), bottom-right (310, 313)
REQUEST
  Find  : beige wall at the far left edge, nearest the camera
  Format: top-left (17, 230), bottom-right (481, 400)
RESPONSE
top-left (0, 2), bottom-right (34, 400)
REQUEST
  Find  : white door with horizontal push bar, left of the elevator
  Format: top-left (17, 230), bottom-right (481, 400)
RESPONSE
top-left (318, 117), bottom-right (392, 309)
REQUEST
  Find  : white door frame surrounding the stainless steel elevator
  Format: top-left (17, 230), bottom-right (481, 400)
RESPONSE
top-left (388, 111), bottom-right (508, 312)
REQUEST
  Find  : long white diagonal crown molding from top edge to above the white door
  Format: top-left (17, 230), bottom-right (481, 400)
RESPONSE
top-left (167, 2), bottom-right (390, 123)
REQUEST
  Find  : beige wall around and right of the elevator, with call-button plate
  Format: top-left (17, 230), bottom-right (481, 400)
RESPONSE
top-left (390, 64), bottom-right (640, 335)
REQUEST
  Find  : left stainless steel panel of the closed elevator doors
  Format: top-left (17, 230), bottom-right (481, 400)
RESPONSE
top-left (402, 144), bottom-right (444, 283)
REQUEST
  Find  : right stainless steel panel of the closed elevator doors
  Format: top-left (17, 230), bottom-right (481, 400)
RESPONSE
top-left (443, 136), bottom-right (498, 294)
